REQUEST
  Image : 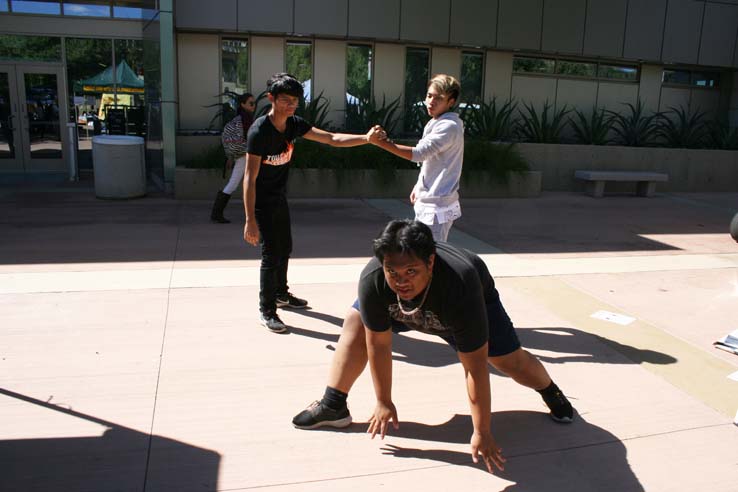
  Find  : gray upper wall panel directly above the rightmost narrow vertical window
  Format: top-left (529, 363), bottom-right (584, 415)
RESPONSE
top-left (450, 0), bottom-right (499, 47)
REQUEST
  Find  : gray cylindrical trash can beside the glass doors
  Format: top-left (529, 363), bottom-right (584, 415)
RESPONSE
top-left (92, 135), bottom-right (146, 198)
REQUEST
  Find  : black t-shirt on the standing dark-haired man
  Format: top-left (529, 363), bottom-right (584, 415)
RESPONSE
top-left (246, 115), bottom-right (312, 203)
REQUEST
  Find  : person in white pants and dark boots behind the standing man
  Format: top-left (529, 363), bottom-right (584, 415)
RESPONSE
top-left (210, 92), bottom-right (256, 224)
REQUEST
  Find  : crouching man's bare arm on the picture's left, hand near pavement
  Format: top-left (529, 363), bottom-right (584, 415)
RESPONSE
top-left (365, 328), bottom-right (399, 439)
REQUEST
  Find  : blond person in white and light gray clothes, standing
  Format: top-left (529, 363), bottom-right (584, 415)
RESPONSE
top-left (371, 74), bottom-right (464, 242)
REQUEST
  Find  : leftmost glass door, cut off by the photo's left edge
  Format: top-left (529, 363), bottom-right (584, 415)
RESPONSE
top-left (0, 65), bottom-right (23, 172)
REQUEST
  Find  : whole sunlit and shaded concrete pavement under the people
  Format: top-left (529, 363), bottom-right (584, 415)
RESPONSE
top-left (0, 187), bottom-right (738, 492)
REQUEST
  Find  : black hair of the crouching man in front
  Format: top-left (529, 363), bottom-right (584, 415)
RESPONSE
top-left (373, 219), bottom-right (436, 263)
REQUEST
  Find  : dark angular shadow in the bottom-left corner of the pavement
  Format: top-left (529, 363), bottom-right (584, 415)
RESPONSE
top-left (0, 388), bottom-right (221, 492)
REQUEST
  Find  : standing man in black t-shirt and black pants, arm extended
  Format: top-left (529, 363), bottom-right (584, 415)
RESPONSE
top-left (243, 73), bottom-right (381, 333)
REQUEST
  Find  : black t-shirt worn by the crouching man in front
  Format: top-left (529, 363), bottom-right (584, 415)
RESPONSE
top-left (359, 243), bottom-right (498, 352)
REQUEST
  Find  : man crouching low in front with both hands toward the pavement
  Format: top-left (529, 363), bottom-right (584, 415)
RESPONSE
top-left (292, 220), bottom-right (574, 473)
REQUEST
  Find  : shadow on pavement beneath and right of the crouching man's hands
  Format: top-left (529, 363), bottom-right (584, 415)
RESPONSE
top-left (326, 411), bottom-right (644, 492)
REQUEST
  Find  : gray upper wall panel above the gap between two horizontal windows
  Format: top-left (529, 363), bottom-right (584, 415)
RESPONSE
top-left (623, 0), bottom-right (667, 60)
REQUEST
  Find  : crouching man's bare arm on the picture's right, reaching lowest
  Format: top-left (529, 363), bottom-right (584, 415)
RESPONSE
top-left (458, 343), bottom-right (505, 473)
